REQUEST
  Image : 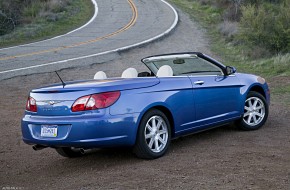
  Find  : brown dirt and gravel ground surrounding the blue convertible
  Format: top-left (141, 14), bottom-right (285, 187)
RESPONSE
top-left (0, 7), bottom-right (290, 190)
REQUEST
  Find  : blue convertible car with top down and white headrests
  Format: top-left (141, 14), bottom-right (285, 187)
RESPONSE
top-left (22, 52), bottom-right (270, 159)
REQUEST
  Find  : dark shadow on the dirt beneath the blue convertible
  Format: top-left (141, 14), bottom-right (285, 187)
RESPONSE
top-left (37, 125), bottom-right (238, 173)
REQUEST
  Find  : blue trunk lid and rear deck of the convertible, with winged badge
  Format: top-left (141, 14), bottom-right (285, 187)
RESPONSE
top-left (30, 77), bottom-right (159, 116)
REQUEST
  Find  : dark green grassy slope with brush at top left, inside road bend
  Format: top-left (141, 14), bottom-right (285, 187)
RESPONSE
top-left (0, 0), bottom-right (94, 47)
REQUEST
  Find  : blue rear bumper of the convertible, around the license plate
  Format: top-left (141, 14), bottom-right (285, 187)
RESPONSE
top-left (22, 110), bottom-right (139, 148)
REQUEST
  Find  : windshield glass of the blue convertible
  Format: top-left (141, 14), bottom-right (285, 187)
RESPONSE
top-left (145, 57), bottom-right (223, 76)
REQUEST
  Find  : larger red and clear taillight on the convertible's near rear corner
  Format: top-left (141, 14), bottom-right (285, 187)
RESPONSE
top-left (71, 91), bottom-right (121, 112)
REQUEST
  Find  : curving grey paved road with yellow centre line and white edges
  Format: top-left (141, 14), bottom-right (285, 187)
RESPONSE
top-left (0, 0), bottom-right (177, 80)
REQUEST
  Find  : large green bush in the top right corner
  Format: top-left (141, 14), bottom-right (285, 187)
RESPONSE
top-left (239, 1), bottom-right (290, 53)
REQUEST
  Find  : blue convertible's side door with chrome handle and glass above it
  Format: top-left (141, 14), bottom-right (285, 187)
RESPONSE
top-left (188, 58), bottom-right (241, 127)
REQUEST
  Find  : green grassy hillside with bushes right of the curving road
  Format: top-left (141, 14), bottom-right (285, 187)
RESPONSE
top-left (171, 0), bottom-right (290, 105)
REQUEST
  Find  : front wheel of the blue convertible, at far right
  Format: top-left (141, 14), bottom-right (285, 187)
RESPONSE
top-left (237, 91), bottom-right (269, 131)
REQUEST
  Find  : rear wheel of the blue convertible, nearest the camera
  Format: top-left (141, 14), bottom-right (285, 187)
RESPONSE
top-left (134, 109), bottom-right (171, 159)
